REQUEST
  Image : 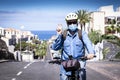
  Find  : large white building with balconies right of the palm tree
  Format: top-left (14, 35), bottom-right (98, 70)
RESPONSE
top-left (90, 5), bottom-right (120, 34)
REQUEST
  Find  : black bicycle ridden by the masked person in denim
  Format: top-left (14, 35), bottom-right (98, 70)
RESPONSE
top-left (49, 56), bottom-right (96, 80)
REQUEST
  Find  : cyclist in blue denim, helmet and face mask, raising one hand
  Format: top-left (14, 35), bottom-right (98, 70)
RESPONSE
top-left (51, 13), bottom-right (95, 80)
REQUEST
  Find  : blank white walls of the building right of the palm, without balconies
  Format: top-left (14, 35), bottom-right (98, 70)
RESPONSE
top-left (90, 5), bottom-right (120, 34)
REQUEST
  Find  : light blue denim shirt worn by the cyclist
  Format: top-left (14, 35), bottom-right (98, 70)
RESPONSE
top-left (52, 31), bottom-right (95, 60)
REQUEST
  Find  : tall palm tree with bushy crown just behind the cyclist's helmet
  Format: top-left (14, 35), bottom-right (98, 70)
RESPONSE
top-left (76, 10), bottom-right (91, 30)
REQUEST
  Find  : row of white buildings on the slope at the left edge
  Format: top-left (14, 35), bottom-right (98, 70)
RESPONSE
top-left (0, 27), bottom-right (34, 52)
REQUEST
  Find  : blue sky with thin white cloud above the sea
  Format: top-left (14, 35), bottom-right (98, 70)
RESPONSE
top-left (0, 0), bottom-right (120, 30)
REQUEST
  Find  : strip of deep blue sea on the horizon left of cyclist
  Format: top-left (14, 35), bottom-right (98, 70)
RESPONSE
top-left (31, 31), bottom-right (56, 40)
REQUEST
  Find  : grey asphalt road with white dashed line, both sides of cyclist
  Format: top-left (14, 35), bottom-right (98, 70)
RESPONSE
top-left (0, 61), bottom-right (120, 80)
